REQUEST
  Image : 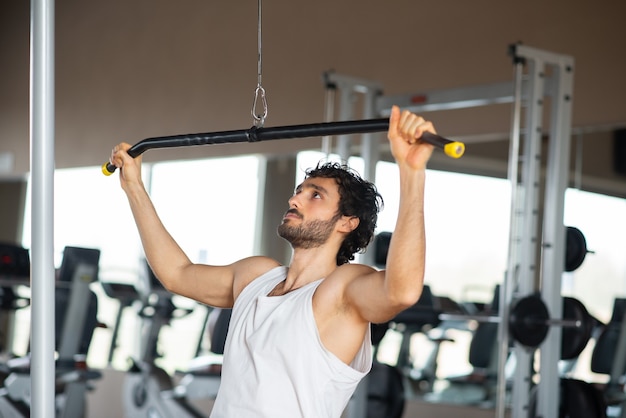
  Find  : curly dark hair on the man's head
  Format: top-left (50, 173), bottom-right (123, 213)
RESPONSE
top-left (305, 162), bottom-right (383, 266)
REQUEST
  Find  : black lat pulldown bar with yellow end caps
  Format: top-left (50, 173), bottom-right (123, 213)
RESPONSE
top-left (102, 118), bottom-right (465, 176)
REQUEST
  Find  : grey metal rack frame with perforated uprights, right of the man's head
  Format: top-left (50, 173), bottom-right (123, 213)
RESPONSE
top-left (325, 44), bottom-right (574, 418)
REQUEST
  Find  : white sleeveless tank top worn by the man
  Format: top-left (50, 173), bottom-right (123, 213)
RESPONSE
top-left (211, 266), bottom-right (372, 418)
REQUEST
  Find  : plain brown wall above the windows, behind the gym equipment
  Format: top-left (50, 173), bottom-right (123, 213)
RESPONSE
top-left (0, 0), bottom-right (626, 192)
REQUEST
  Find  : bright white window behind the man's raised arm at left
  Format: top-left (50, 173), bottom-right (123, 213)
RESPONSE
top-left (15, 156), bottom-right (259, 371)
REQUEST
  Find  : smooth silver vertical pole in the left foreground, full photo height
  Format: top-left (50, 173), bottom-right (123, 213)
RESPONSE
top-left (30, 0), bottom-right (55, 418)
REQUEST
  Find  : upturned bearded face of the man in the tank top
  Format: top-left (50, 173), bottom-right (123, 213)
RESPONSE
top-left (278, 178), bottom-right (341, 249)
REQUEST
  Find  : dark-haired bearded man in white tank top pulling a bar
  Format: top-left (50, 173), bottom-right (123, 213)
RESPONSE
top-left (111, 106), bottom-right (435, 418)
